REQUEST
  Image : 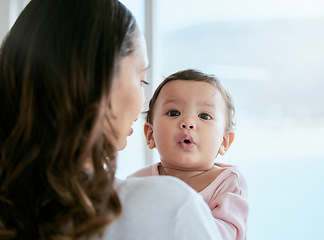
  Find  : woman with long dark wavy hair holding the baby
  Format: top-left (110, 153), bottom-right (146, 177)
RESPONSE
top-left (0, 0), bottom-right (218, 239)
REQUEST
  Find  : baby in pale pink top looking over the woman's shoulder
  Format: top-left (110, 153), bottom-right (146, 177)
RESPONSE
top-left (130, 69), bottom-right (249, 240)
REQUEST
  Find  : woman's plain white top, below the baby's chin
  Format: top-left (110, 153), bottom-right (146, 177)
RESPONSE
top-left (93, 176), bottom-right (222, 240)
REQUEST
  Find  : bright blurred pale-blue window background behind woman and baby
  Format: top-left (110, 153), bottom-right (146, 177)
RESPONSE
top-left (0, 0), bottom-right (324, 240)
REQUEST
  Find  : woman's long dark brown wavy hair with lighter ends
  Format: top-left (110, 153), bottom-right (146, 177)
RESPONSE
top-left (0, 0), bottom-right (137, 240)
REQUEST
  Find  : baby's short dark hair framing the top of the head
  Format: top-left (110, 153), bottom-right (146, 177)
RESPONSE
top-left (144, 69), bottom-right (235, 130)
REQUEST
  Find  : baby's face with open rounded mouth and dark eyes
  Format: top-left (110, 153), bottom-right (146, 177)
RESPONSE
top-left (153, 80), bottom-right (227, 170)
